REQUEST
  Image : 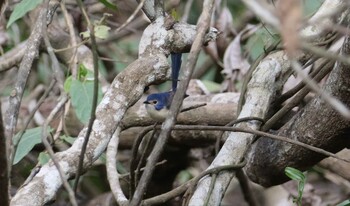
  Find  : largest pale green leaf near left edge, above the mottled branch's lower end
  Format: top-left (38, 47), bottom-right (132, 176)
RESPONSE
top-left (13, 127), bottom-right (52, 165)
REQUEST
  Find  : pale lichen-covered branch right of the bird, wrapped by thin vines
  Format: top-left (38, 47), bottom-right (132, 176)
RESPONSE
top-left (190, 1), bottom-right (348, 205)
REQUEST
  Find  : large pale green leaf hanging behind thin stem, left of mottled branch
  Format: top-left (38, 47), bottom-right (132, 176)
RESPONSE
top-left (69, 71), bottom-right (102, 124)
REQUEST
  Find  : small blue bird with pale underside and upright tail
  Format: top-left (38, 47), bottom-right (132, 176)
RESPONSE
top-left (143, 53), bottom-right (182, 122)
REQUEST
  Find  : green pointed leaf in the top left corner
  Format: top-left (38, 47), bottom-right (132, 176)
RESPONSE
top-left (6, 0), bottom-right (43, 28)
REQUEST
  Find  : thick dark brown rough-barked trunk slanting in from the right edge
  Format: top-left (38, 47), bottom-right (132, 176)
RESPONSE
top-left (246, 37), bottom-right (350, 186)
